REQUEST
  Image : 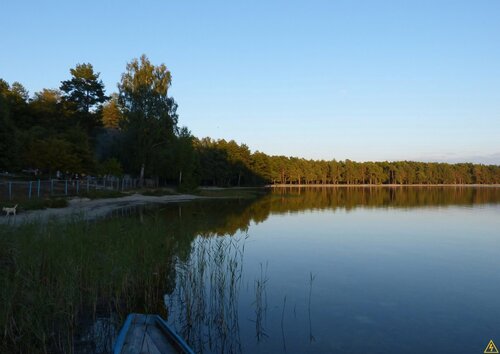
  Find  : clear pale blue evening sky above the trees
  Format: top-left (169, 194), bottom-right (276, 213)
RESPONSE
top-left (0, 0), bottom-right (500, 164)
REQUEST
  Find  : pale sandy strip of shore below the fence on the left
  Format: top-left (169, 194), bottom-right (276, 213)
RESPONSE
top-left (0, 194), bottom-right (206, 224)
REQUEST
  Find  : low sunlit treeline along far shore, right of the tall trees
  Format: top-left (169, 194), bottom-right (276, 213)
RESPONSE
top-left (195, 138), bottom-right (500, 186)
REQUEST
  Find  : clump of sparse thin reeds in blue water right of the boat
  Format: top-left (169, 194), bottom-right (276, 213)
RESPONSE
top-left (166, 236), bottom-right (246, 353)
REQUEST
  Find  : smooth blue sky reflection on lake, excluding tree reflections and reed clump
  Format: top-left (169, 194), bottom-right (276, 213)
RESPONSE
top-left (166, 191), bottom-right (500, 353)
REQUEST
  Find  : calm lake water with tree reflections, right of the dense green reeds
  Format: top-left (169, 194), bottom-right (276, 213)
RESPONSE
top-left (142, 187), bottom-right (500, 353)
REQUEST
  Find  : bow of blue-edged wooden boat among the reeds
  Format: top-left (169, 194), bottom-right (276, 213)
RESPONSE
top-left (113, 313), bottom-right (194, 354)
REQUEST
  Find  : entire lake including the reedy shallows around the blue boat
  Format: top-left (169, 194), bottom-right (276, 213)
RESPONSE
top-left (0, 187), bottom-right (500, 353)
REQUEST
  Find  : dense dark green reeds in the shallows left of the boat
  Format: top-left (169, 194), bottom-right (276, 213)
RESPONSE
top-left (0, 214), bottom-right (179, 353)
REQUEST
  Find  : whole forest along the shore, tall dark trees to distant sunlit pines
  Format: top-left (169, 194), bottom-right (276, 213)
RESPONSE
top-left (0, 55), bottom-right (500, 188)
